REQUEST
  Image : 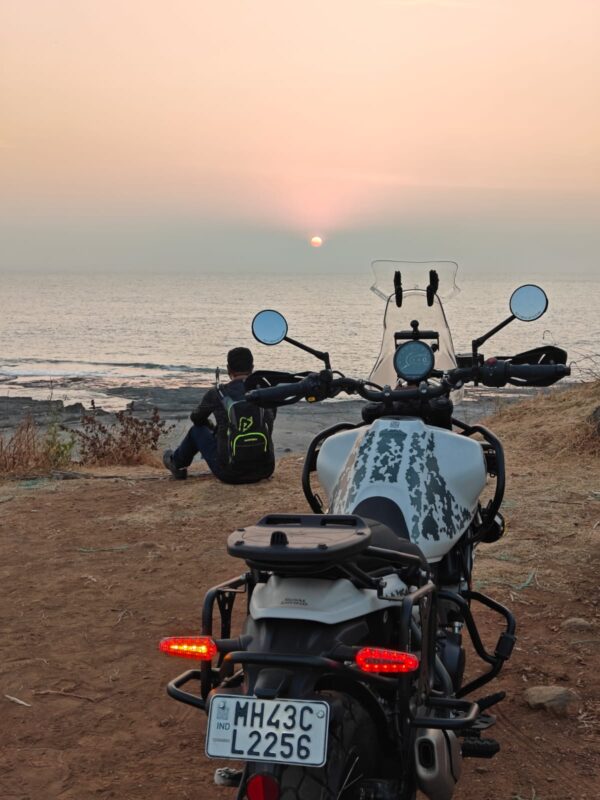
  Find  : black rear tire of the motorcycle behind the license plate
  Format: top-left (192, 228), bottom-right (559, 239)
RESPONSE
top-left (250, 692), bottom-right (414, 800)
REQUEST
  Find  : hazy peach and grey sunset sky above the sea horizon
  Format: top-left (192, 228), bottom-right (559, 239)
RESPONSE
top-left (0, 0), bottom-right (600, 274)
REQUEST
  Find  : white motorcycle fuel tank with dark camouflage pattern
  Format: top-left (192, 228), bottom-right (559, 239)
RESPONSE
top-left (317, 417), bottom-right (487, 562)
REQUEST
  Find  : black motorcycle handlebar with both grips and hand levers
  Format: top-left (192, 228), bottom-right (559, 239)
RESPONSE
top-left (241, 359), bottom-right (571, 405)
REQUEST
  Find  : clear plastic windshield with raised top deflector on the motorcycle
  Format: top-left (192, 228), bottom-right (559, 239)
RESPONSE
top-left (369, 261), bottom-right (460, 386)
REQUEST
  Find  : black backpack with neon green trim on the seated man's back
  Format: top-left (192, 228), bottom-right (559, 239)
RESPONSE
top-left (217, 389), bottom-right (273, 467)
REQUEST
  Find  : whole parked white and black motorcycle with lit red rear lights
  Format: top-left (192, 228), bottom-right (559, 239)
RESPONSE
top-left (160, 262), bottom-right (570, 800)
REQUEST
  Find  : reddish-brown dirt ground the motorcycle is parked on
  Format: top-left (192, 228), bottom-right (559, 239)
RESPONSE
top-left (0, 390), bottom-right (600, 800)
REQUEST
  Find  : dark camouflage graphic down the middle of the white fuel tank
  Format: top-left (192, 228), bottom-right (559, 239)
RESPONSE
top-left (331, 420), bottom-right (473, 544)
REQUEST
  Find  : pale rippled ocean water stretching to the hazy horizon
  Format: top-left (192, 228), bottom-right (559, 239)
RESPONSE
top-left (0, 270), bottom-right (600, 408)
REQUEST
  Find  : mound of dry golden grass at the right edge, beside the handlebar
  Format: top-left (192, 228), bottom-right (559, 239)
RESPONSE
top-left (494, 380), bottom-right (600, 456)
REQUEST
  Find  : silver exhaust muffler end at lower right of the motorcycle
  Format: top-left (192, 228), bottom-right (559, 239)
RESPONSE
top-left (415, 728), bottom-right (461, 800)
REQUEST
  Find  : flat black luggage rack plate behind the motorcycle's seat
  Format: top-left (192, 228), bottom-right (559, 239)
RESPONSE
top-left (227, 514), bottom-right (371, 568)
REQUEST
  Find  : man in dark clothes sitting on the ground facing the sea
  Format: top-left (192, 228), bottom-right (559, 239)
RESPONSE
top-left (163, 347), bottom-right (275, 483)
